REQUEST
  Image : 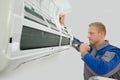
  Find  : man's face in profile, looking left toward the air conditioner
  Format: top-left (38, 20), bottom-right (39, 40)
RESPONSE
top-left (88, 26), bottom-right (101, 45)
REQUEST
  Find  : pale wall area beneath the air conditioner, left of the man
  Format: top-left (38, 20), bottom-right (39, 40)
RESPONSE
top-left (0, 48), bottom-right (83, 80)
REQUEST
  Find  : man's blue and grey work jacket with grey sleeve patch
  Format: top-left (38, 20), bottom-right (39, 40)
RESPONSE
top-left (82, 40), bottom-right (120, 80)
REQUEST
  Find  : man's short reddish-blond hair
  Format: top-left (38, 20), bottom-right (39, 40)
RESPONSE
top-left (89, 22), bottom-right (106, 36)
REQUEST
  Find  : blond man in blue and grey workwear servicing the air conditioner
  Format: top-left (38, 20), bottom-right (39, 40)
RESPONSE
top-left (73, 22), bottom-right (120, 80)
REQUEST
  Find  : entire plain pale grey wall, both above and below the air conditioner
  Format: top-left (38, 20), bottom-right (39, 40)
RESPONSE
top-left (0, 0), bottom-right (120, 80)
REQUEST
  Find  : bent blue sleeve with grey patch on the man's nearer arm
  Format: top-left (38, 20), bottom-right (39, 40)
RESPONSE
top-left (82, 52), bottom-right (120, 75)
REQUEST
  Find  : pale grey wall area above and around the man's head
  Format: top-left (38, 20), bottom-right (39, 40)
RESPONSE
top-left (66, 0), bottom-right (120, 47)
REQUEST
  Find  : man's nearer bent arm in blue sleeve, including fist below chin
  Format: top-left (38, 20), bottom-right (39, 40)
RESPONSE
top-left (80, 43), bottom-right (120, 76)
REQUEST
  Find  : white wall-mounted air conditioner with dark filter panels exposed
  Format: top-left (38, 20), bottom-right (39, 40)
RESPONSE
top-left (0, 0), bottom-right (72, 72)
